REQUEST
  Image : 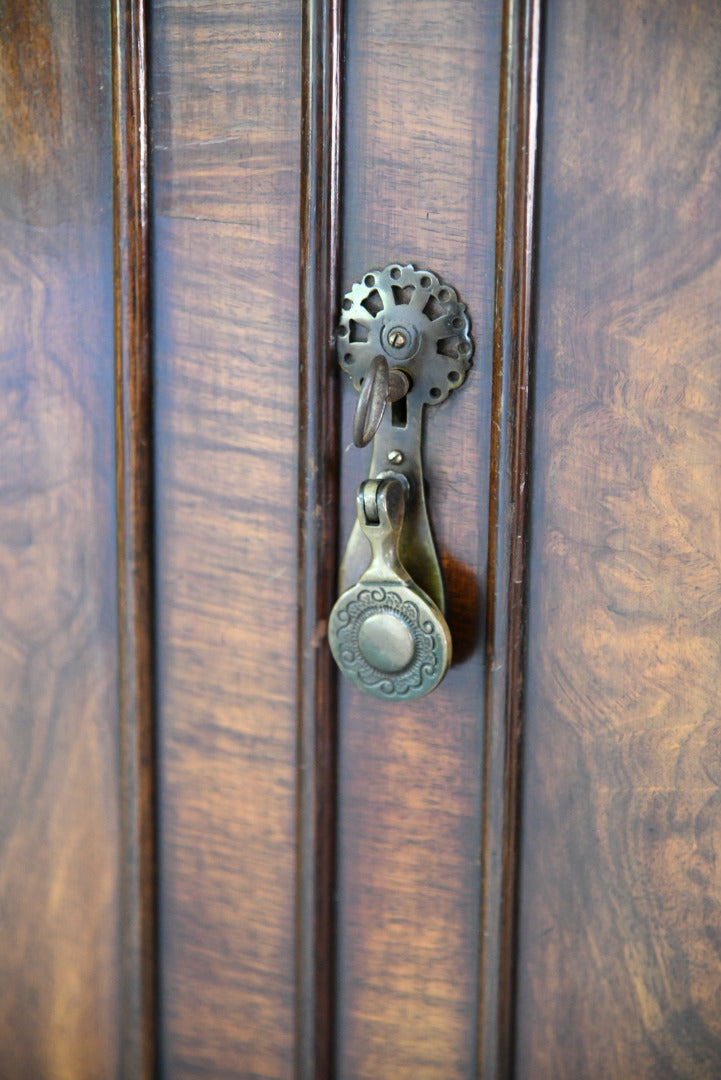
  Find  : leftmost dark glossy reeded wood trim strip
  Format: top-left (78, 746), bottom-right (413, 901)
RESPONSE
top-left (111, 0), bottom-right (157, 1080)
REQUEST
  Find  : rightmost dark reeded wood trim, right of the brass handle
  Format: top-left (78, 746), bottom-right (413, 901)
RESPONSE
top-left (478, 0), bottom-right (541, 1080)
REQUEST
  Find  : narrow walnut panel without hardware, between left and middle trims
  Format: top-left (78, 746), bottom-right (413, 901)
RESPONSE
top-left (152, 0), bottom-right (300, 1080)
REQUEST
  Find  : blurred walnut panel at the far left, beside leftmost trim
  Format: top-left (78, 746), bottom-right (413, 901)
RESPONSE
top-left (0, 0), bottom-right (121, 1080)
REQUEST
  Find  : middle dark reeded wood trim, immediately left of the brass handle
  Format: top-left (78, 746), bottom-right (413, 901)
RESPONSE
top-left (296, 0), bottom-right (342, 1080)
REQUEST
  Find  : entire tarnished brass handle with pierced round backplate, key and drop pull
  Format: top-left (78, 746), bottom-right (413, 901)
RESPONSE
top-left (331, 264), bottom-right (473, 699)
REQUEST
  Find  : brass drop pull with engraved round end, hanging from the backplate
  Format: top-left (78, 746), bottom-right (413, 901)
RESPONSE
top-left (328, 480), bottom-right (451, 701)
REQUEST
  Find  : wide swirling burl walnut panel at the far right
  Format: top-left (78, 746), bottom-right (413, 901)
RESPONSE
top-left (517, 0), bottom-right (721, 1080)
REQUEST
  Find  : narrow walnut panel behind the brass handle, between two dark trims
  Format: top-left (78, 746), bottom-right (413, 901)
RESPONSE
top-left (337, 0), bottom-right (501, 1080)
